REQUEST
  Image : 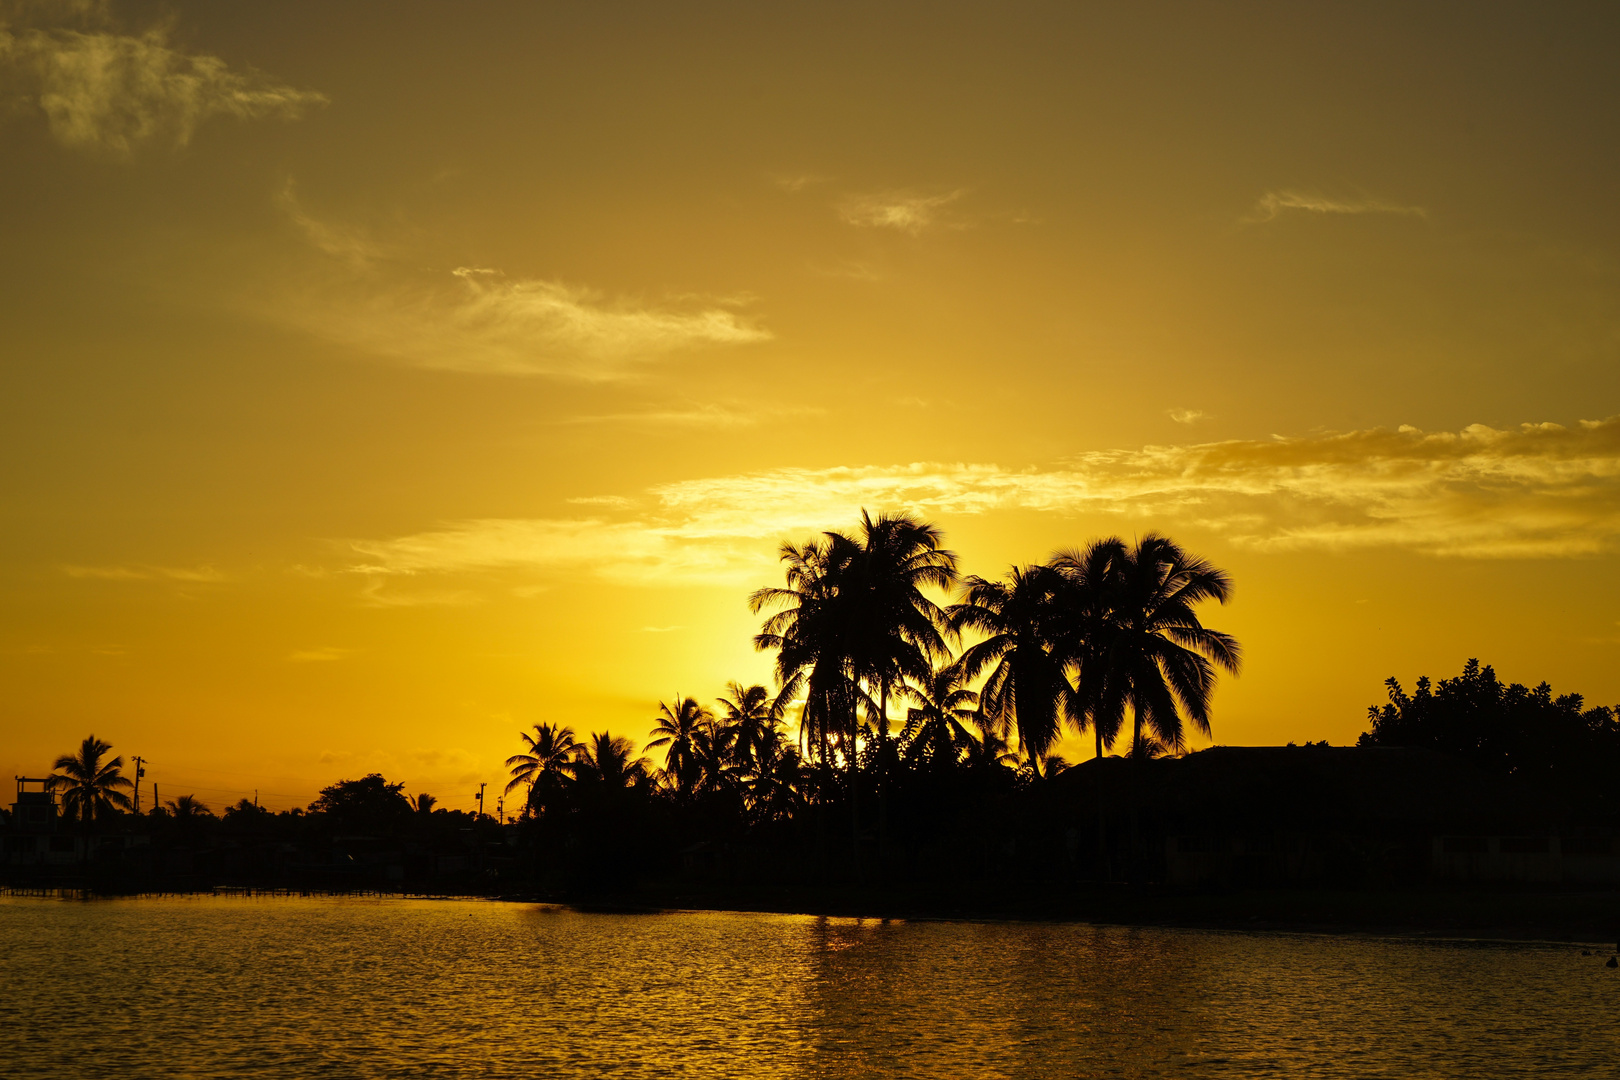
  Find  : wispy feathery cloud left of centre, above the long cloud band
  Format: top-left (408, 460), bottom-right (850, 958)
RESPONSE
top-left (293, 267), bottom-right (771, 381)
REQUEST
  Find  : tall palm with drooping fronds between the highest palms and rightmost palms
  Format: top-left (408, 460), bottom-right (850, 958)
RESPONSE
top-left (951, 567), bottom-right (1072, 776)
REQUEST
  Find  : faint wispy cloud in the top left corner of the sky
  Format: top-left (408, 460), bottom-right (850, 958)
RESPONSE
top-left (0, 5), bottom-right (327, 157)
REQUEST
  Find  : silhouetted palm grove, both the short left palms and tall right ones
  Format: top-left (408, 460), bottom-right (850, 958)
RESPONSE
top-left (507, 513), bottom-right (1241, 827)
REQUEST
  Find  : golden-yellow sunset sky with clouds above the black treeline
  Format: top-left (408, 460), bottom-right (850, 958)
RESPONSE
top-left (0, 2), bottom-right (1620, 808)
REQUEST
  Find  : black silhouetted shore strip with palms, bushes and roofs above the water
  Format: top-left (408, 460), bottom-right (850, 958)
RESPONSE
top-left (3, 517), bottom-right (1620, 941)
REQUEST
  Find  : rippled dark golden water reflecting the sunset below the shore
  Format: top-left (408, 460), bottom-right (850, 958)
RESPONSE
top-left (0, 897), bottom-right (1620, 1080)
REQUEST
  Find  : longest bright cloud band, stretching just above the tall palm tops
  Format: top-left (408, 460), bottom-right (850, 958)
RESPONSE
top-left (341, 418), bottom-right (1620, 599)
